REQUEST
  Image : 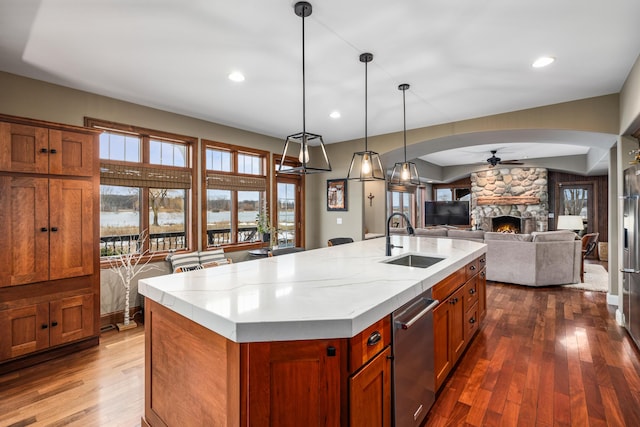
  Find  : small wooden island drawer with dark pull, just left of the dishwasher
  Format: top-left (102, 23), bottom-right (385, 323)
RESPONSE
top-left (349, 316), bottom-right (391, 373)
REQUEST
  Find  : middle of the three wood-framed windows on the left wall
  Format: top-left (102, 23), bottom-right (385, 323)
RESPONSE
top-left (202, 140), bottom-right (269, 248)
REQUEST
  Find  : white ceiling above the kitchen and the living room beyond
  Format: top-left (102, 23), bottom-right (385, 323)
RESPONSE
top-left (0, 0), bottom-right (640, 172)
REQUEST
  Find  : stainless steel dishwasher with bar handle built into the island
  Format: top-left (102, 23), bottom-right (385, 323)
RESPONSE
top-left (393, 290), bottom-right (438, 427)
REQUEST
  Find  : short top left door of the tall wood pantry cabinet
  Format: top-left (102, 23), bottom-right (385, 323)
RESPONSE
top-left (0, 122), bottom-right (49, 173)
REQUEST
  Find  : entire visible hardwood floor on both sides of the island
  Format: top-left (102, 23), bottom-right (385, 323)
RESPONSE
top-left (0, 266), bottom-right (640, 427)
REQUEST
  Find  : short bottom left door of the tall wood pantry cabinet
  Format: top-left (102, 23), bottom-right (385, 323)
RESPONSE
top-left (0, 303), bottom-right (49, 360)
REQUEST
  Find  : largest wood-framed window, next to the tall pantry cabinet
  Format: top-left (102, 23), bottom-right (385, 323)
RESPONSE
top-left (85, 118), bottom-right (197, 256)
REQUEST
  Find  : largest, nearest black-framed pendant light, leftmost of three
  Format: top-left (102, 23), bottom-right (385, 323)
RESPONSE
top-left (278, 1), bottom-right (331, 175)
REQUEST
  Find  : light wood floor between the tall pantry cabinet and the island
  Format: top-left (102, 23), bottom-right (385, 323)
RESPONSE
top-left (0, 326), bottom-right (144, 427)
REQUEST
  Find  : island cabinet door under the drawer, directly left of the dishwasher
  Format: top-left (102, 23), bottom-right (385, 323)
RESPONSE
top-left (349, 347), bottom-right (391, 427)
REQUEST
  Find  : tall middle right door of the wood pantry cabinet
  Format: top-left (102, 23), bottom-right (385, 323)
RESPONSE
top-left (49, 179), bottom-right (96, 280)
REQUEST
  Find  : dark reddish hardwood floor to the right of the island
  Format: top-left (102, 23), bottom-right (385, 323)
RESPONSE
top-left (426, 262), bottom-right (640, 427)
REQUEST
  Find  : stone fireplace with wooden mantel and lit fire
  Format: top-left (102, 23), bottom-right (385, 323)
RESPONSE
top-left (471, 166), bottom-right (549, 233)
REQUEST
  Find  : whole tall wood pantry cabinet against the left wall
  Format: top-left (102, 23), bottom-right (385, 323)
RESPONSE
top-left (0, 115), bottom-right (100, 373)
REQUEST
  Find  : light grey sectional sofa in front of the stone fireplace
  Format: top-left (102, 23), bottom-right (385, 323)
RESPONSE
top-left (391, 227), bottom-right (582, 286)
